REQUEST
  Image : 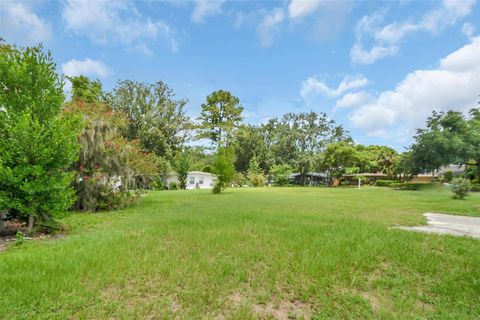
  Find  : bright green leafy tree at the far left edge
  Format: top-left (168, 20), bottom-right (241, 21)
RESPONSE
top-left (0, 46), bottom-right (78, 232)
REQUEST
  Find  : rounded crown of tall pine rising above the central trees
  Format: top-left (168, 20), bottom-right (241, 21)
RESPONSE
top-left (198, 90), bottom-right (243, 148)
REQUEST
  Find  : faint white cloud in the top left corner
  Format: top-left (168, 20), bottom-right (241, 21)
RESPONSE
top-left (0, 2), bottom-right (52, 45)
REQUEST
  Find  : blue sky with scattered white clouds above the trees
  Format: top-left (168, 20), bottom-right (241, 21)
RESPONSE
top-left (0, 0), bottom-right (480, 151)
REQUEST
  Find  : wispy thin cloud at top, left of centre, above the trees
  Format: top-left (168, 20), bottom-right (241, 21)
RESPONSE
top-left (62, 0), bottom-right (178, 52)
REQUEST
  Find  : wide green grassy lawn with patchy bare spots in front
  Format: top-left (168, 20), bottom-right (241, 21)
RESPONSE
top-left (0, 187), bottom-right (480, 319)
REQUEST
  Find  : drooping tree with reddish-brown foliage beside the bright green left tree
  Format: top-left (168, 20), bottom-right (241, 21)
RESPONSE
top-left (66, 77), bottom-right (159, 211)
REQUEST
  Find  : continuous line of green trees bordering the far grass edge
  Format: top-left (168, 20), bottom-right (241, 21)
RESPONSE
top-left (0, 43), bottom-right (480, 232)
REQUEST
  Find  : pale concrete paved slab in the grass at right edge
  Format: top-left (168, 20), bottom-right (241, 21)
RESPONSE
top-left (399, 212), bottom-right (480, 239)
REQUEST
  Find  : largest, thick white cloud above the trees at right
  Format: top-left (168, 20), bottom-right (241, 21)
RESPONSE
top-left (350, 37), bottom-right (480, 138)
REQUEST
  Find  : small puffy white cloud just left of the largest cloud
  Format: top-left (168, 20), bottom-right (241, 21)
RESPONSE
top-left (300, 75), bottom-right (368, 99)
